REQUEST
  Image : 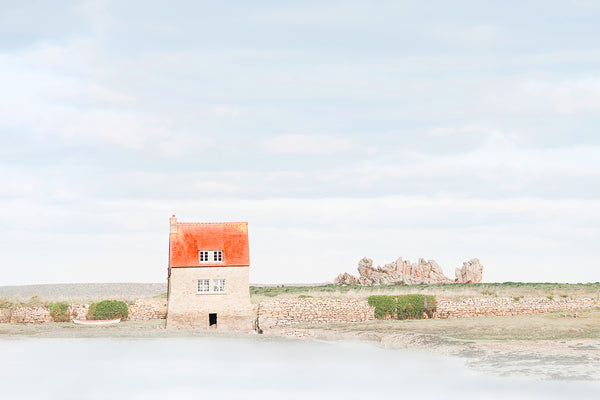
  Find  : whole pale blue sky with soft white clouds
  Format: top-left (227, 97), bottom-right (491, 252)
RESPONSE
top-left (0, 0), bottom-right (600, 285)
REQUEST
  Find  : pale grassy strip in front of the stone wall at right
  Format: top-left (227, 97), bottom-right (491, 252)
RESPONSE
top-left (301, 309), bottom-right (600, 341)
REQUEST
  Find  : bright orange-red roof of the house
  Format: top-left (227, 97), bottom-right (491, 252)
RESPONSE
top-left (169, 220), bottom-right (250, 267)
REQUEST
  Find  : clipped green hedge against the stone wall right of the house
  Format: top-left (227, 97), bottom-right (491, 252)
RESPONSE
top-left (369, 294), bottom-right (437, 319)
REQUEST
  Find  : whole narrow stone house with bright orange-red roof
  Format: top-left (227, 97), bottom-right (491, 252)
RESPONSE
top-left (166, 215), bottom-right (254, 331)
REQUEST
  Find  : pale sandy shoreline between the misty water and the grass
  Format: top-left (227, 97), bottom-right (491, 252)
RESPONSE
top-left (0, 320), bottom-right (600, 381)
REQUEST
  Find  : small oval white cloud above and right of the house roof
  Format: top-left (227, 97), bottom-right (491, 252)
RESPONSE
top-left (263, 135), bottom-right (351, 154)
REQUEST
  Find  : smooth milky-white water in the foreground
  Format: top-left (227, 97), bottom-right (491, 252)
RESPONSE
top-left (0, 337), bottom-right (600, 400)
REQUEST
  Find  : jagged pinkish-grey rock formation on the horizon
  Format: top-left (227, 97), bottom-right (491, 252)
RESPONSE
top-left (333, 257), bottom-right (483, 286)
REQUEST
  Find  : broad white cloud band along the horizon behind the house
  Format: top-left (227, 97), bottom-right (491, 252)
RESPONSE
top-left (0, 195), bottom-right (600, 283)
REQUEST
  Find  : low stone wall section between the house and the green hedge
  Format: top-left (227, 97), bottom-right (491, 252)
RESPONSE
top-left (258, 297), bottom-right (375, 329)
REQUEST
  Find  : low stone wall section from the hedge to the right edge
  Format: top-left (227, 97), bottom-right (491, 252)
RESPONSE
top-left (433, 297), bottom-right (599, 318)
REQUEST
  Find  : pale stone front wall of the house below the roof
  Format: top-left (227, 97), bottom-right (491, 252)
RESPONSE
top-left (167, 267), bottom-right (255, 331)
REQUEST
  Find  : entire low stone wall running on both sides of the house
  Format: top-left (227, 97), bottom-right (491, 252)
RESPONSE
top-left (0, 297), bottom-right (600, 329)
